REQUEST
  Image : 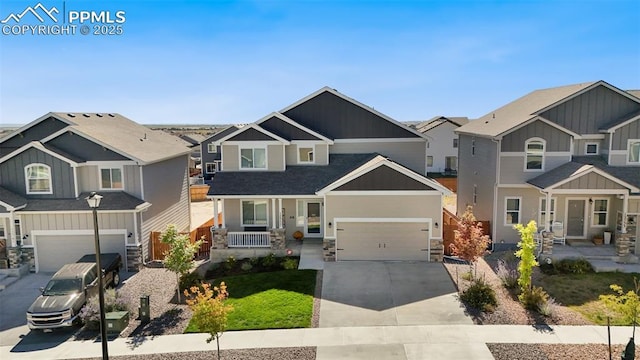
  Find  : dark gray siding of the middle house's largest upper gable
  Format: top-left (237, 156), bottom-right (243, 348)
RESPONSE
top-left (284, 92), bottom-right (418, 139)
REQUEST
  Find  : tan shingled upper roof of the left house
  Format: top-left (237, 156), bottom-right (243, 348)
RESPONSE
top-left (0, 112), bottom-right (191, 164)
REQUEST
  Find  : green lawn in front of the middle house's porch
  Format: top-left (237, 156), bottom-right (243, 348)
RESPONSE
top-left (185, 270), bottom-right (316, 332)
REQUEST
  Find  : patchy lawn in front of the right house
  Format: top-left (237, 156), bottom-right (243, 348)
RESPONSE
top-left (535, 272), bottom-right (640, 325)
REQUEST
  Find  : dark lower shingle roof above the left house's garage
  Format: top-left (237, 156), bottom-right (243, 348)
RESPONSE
top-left (22, 191), bottom-right (145, 211)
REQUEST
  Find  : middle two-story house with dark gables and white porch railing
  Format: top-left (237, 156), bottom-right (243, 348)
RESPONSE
top-left (209, 87), bottom-right (449, 261)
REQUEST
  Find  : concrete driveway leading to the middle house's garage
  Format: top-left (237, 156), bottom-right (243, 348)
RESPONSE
top-left (320, 261), bottom-right (473, 327)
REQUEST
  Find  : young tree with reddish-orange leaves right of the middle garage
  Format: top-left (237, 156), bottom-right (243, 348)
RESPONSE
top-left (451, 206), bottom-right (490, 272)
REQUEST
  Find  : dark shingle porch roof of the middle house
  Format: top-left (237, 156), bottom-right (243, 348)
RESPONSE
top-left (208, 154), bottom-right (378, 196)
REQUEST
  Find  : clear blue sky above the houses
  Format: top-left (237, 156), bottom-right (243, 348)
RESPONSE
top-left (0, 0), bottom-right (640, 124)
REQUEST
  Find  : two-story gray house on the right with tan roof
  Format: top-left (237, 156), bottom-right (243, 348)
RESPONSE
top-left (456, 81), bottom-right (640, 252)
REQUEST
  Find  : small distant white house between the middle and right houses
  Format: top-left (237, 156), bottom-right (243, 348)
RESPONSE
top-left (415, 116), bottom-right (469, 175)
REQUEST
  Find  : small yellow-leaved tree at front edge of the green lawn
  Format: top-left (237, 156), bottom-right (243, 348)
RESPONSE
top-left (184, 282), bottom-right (233, 360)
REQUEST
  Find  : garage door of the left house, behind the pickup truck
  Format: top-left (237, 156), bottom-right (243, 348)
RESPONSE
top-left (36, 235), bottom-right (126, 272)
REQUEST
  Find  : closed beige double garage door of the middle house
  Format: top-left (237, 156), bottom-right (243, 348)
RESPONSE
top-left (336, 222), bottom-right (429, 261)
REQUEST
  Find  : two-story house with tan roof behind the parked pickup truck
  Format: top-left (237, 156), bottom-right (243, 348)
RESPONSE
top-left (0, 113), bottom-right (191, 272)
